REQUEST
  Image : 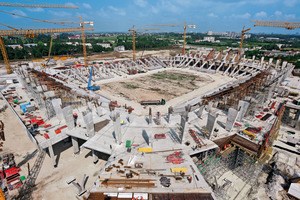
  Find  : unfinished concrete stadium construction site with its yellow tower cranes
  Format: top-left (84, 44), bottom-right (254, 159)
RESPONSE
top-left (0, 1), bottom-right (300, 200)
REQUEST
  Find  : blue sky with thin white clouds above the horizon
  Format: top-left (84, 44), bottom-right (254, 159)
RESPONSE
top-left (0, 0), bottom-right (300, 33)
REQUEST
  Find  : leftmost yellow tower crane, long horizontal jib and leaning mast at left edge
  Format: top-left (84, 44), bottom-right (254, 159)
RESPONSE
top-left (0, 27), bottom-right (94, 74)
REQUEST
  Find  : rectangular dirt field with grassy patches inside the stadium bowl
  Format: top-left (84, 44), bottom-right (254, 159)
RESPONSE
top-left (100, 71), bottom-right (213, 102)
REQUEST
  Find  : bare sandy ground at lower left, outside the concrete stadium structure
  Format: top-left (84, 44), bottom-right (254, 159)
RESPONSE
top-left (0, 100), bottom-right (106, 200)
